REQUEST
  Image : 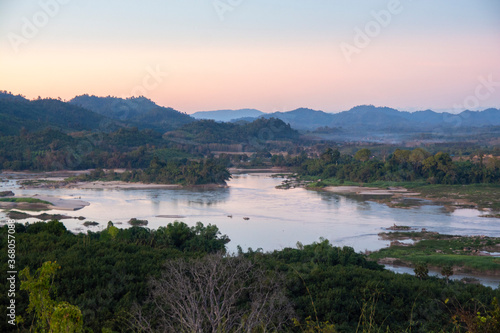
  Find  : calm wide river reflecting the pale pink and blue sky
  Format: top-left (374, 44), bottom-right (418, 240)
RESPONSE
top-left (0, 173), bottom-right (500, 286)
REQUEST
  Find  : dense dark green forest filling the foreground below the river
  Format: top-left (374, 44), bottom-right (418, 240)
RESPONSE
top-left (0, 220), bottom-right (500, 332)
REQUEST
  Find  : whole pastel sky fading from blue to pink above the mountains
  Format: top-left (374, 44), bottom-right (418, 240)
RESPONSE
top-left (0, 0), bottom-right (500, 113)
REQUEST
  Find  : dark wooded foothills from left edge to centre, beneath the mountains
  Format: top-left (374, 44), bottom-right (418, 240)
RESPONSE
top-left (0, 119), bottom-right (298, 171)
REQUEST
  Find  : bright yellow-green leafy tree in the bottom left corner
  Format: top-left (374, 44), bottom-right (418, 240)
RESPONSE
top-left (19, 261), bottom-right (83, 333)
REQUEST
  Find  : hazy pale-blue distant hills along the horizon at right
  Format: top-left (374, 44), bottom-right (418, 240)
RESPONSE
top-left (242, 105), bottom-right (500, 132)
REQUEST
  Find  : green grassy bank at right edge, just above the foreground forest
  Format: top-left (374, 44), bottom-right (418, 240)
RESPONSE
top-left (369, 232), bottom-right (500, 273)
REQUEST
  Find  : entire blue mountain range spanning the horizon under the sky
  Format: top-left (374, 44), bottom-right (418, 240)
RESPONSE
top-left (0, 91), bottom-right (500, 135)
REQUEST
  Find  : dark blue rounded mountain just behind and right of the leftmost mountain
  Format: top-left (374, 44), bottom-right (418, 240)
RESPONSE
top-left (69, 95), bottom-right (194, 132)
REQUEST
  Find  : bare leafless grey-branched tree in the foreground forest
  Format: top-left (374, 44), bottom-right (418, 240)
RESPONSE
top-left (133, 254), bottom-right (293, 333)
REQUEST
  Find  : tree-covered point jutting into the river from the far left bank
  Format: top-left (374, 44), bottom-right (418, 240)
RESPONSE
top-left (74, 156), bottom-right (231, 185)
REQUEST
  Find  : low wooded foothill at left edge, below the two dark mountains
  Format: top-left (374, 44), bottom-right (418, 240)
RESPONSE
top-left (0, 128), bottom-right (193, 171)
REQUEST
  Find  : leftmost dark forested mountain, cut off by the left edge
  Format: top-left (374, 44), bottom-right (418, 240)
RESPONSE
top-left (0, 94), bottom-right (110, 135)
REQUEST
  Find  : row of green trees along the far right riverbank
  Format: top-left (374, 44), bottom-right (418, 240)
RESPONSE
top-left (298, 148), bottom-right (500, 184)
